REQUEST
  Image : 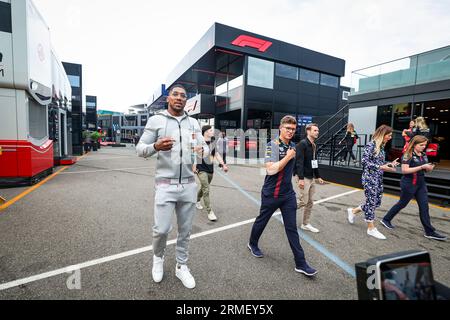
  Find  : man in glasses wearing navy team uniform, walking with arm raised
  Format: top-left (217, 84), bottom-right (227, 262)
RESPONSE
top-left (248, 116), bottom-right (317, 277)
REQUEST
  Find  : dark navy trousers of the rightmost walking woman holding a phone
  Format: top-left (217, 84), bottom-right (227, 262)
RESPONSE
top-left (384, 177), bottom-right (436, 235)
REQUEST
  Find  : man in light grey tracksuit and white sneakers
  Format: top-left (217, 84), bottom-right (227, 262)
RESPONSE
top-left (136, 85), bottom-right (209, 289)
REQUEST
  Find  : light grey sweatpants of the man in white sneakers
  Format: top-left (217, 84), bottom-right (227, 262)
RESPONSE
top-left (153, 183), bottom-right (197, 264)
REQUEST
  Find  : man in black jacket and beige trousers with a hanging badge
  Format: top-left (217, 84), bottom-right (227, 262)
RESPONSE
top-left (296, 123), bottom-right (324, 233)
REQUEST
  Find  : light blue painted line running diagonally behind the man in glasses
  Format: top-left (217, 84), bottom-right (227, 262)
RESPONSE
top-left (216, 171), bottom-right (356, 278)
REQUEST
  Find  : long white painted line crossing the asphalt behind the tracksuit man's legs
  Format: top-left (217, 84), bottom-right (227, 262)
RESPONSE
top-left (0, 189), bottom-right (361, 291)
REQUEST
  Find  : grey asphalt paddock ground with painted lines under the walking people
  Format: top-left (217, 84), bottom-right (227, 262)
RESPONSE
top-left (0, 146), bottom-right (450, 300)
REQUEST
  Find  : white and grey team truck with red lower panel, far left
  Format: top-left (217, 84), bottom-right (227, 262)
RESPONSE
top-left (0, 0), bottom-right (72, 185)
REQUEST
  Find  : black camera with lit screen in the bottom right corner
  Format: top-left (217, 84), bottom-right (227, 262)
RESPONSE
top-left (355, 250), bottom-right (450, 300)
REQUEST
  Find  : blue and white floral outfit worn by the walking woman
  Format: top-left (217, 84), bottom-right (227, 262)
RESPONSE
top-left (361, 141), bottom-right (386, 222)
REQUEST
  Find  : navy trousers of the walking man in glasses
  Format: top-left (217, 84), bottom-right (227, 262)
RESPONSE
top-left (250, 193), bottom-right (306, 268)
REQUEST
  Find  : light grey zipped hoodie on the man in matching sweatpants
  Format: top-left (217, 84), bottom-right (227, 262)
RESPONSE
top-left (136, 110), bottom-right (209, 183)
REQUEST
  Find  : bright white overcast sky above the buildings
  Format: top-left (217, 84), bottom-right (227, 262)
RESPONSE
top-left (33, 0), bottom-right (450, 111)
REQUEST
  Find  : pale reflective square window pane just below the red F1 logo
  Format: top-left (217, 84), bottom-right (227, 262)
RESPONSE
top-left (248, 57), bottom-right (275, 89)
